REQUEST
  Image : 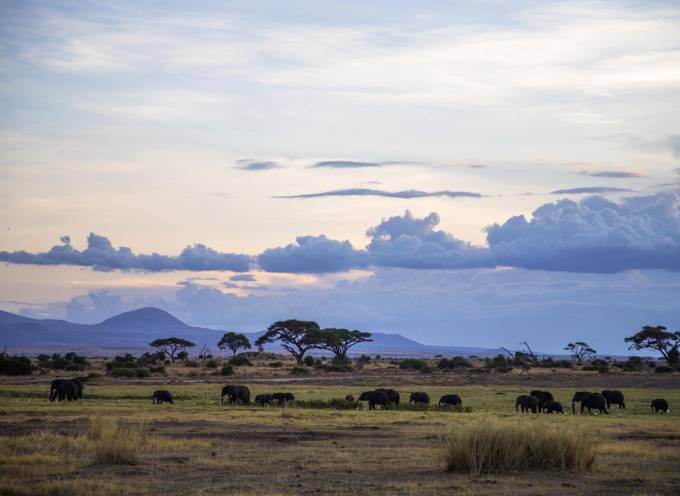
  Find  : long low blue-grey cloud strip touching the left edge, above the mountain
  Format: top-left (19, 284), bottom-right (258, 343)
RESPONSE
top-left (0, 233), bottom-right (251, 272)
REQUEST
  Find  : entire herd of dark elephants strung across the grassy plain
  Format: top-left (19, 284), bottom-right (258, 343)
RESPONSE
top-left (49, 377), bottom-right (671, 415)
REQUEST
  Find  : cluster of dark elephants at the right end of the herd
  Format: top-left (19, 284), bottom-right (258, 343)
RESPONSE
top-left (515, 389), bottom-right (671, 415)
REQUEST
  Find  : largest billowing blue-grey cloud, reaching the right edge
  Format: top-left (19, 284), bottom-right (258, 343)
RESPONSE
top-left (487, 191), bottom-right (680, 273)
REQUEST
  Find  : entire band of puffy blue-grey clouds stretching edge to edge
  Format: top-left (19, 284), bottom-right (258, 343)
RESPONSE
top-left (0, 191), bottom-right (680, 274)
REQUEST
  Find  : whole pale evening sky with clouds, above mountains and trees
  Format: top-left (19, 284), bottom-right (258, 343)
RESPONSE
top-left (0, 0), bottom-right (680, 353)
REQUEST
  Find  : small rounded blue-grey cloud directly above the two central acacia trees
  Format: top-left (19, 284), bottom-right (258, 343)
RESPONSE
top-left (258, 234), bottom-right (366, 274)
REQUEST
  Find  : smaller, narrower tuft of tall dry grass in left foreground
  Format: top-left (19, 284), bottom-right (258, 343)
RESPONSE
top-left (87, 417), bottom-right (147, 465)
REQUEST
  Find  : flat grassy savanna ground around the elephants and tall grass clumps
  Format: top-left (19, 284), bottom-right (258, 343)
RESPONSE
top-left (0, 367), bottom-right (680, 495)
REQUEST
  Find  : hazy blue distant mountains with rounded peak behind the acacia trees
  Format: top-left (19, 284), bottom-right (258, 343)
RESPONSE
top-left (0, 307), bottom-right (499, 356)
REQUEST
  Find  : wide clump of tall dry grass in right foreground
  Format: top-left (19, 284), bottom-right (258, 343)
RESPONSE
top-left (443, 418), bottom-right (597, 474)
